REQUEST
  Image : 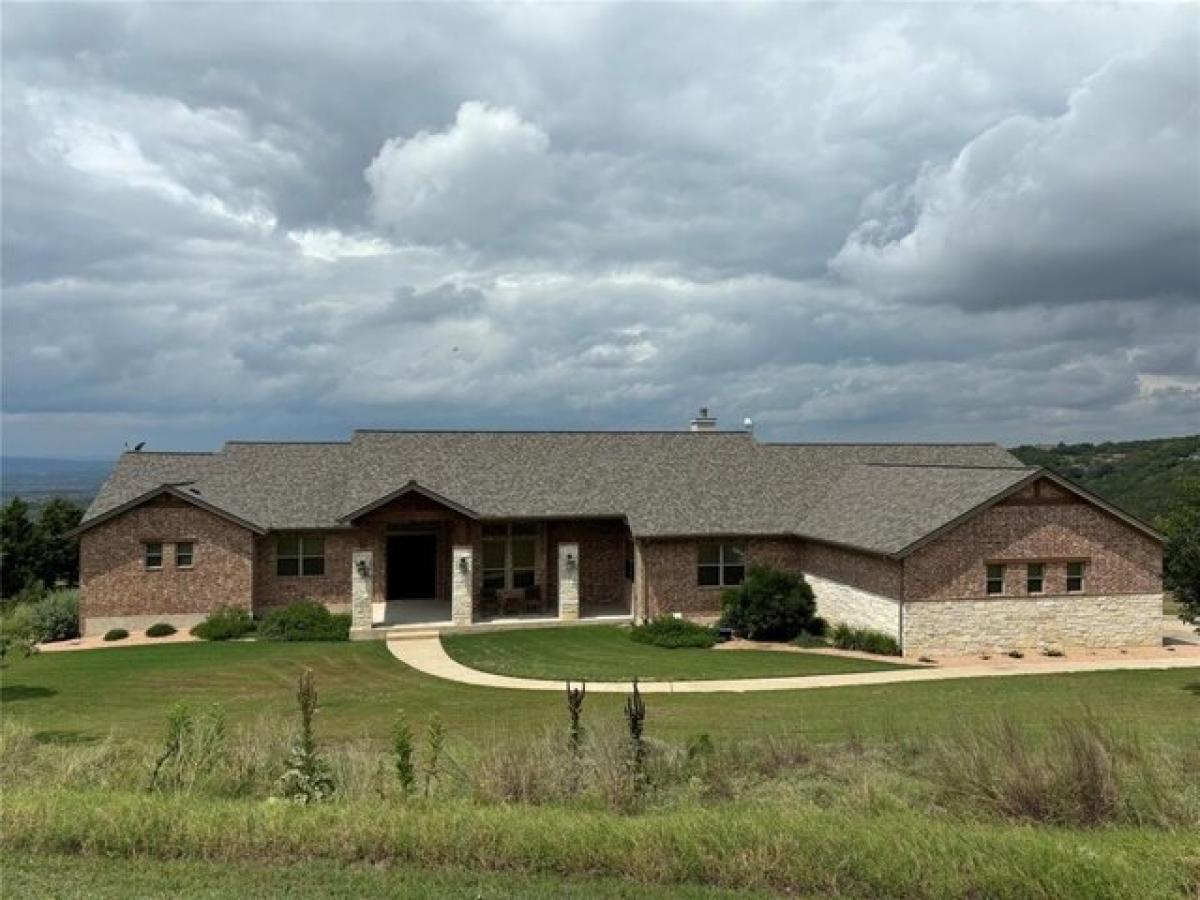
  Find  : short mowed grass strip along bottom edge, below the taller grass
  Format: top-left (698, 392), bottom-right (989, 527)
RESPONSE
top-left (0, 853), bottom-right (767, 900)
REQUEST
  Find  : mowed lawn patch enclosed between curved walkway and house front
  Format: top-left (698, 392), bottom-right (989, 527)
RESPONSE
top-left (442, 625), bottom-right (908, 682)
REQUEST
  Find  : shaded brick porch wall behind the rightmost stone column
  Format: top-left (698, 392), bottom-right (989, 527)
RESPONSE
top-left (545, 520), bottom-right (634, 616)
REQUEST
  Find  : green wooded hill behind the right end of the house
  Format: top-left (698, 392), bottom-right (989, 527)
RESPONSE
top-left (1012, 434), bottom-right (1200, 523)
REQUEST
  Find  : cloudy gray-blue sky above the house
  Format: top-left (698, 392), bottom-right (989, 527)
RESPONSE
top-left (2, 2), bottom-right (1200, 456)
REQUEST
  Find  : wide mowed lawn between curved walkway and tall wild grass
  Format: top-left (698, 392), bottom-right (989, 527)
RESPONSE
top-left (0, 642), bottom-right (1200, 746)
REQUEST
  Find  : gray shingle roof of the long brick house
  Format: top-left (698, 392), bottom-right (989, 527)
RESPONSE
top-left (84, 431), bottom-right (1030, 552)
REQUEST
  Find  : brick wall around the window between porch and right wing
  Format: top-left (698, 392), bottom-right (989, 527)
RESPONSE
top-left (642, 538), bottom-right (804, 619)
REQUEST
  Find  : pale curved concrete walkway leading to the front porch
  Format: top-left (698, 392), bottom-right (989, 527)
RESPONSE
top-left (388, 637), bottom-right (1200, 694)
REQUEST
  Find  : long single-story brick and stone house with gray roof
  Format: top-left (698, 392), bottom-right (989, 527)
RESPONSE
top-left (78, 414), bottom-right (1163, 655)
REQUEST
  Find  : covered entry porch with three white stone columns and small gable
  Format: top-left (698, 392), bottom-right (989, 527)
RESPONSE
top-left (347, 484), bottom-right (634, 638)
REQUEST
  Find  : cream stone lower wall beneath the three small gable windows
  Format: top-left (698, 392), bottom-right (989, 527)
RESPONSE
top-left (902, 593), bottom-right (1163, 656)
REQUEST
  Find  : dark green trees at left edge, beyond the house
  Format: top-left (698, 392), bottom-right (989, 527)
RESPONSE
top-left (0, 497), bottom-right (84, 596)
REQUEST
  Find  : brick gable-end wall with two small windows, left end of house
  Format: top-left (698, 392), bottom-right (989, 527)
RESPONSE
top-left (79, 496), bottom-right (254, 634)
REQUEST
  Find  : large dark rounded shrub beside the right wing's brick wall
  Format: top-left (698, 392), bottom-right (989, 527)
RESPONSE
top-left (721, 565), bottom-right (817, 641)
